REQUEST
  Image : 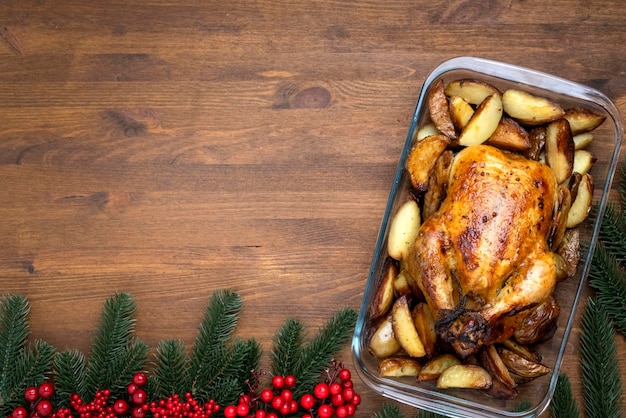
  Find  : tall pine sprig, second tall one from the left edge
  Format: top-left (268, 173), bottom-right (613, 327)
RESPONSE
top-left (85, 293), bottom-right (147, 399)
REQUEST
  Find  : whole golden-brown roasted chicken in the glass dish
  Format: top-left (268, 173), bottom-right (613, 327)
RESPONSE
top-left (406, 145), bottom-right (558, 358)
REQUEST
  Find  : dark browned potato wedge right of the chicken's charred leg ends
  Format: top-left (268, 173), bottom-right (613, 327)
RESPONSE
top-left (513, 296), bottom-right (561, 345)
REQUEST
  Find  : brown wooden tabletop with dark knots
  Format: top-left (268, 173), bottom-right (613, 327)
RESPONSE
top-left (0, 0), bottom-right (626, 416)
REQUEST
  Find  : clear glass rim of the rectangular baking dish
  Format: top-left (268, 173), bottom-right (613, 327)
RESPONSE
top-left (352, 56), bottom-right (623, 418)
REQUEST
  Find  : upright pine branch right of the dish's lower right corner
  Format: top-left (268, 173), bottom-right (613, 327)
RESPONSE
top-left (580, 298), bottom-right (622, 418)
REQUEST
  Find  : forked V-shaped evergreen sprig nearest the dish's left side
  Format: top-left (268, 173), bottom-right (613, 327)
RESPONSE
top-left (272, 308), bottom-right (357, 397)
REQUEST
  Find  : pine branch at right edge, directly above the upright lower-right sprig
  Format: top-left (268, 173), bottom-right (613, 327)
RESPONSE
top-left (589, 241), bottom-right (626, 335)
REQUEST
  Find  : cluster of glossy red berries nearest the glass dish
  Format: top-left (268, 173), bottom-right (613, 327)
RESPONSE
top-left (223, 363), bottom-right (361, 418)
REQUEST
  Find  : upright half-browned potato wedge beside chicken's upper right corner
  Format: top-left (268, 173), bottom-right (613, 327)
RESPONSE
top-left (546, 118), bottom-right (575, 183)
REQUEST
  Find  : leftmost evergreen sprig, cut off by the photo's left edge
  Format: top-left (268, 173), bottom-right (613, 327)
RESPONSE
top-left (0, 295), bottom-right (54, 416)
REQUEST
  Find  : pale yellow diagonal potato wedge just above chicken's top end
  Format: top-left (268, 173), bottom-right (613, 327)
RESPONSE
top-left (459, 94), bottom-right (502, 146)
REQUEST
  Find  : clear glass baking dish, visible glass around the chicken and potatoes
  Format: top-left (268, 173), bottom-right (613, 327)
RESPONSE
top-left (352, 57), bottom-right (623, 418)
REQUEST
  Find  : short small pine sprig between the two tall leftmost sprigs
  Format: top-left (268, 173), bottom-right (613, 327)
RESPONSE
top-left (53, 350), bottom-right (89, 407)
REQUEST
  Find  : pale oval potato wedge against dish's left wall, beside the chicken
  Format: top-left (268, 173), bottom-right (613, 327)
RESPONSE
top-left (387, 200), bottom-right (421, 260)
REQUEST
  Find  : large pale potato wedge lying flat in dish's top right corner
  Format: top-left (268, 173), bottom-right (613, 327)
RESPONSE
top-left (502, 89), bottom-right (565, 126)
